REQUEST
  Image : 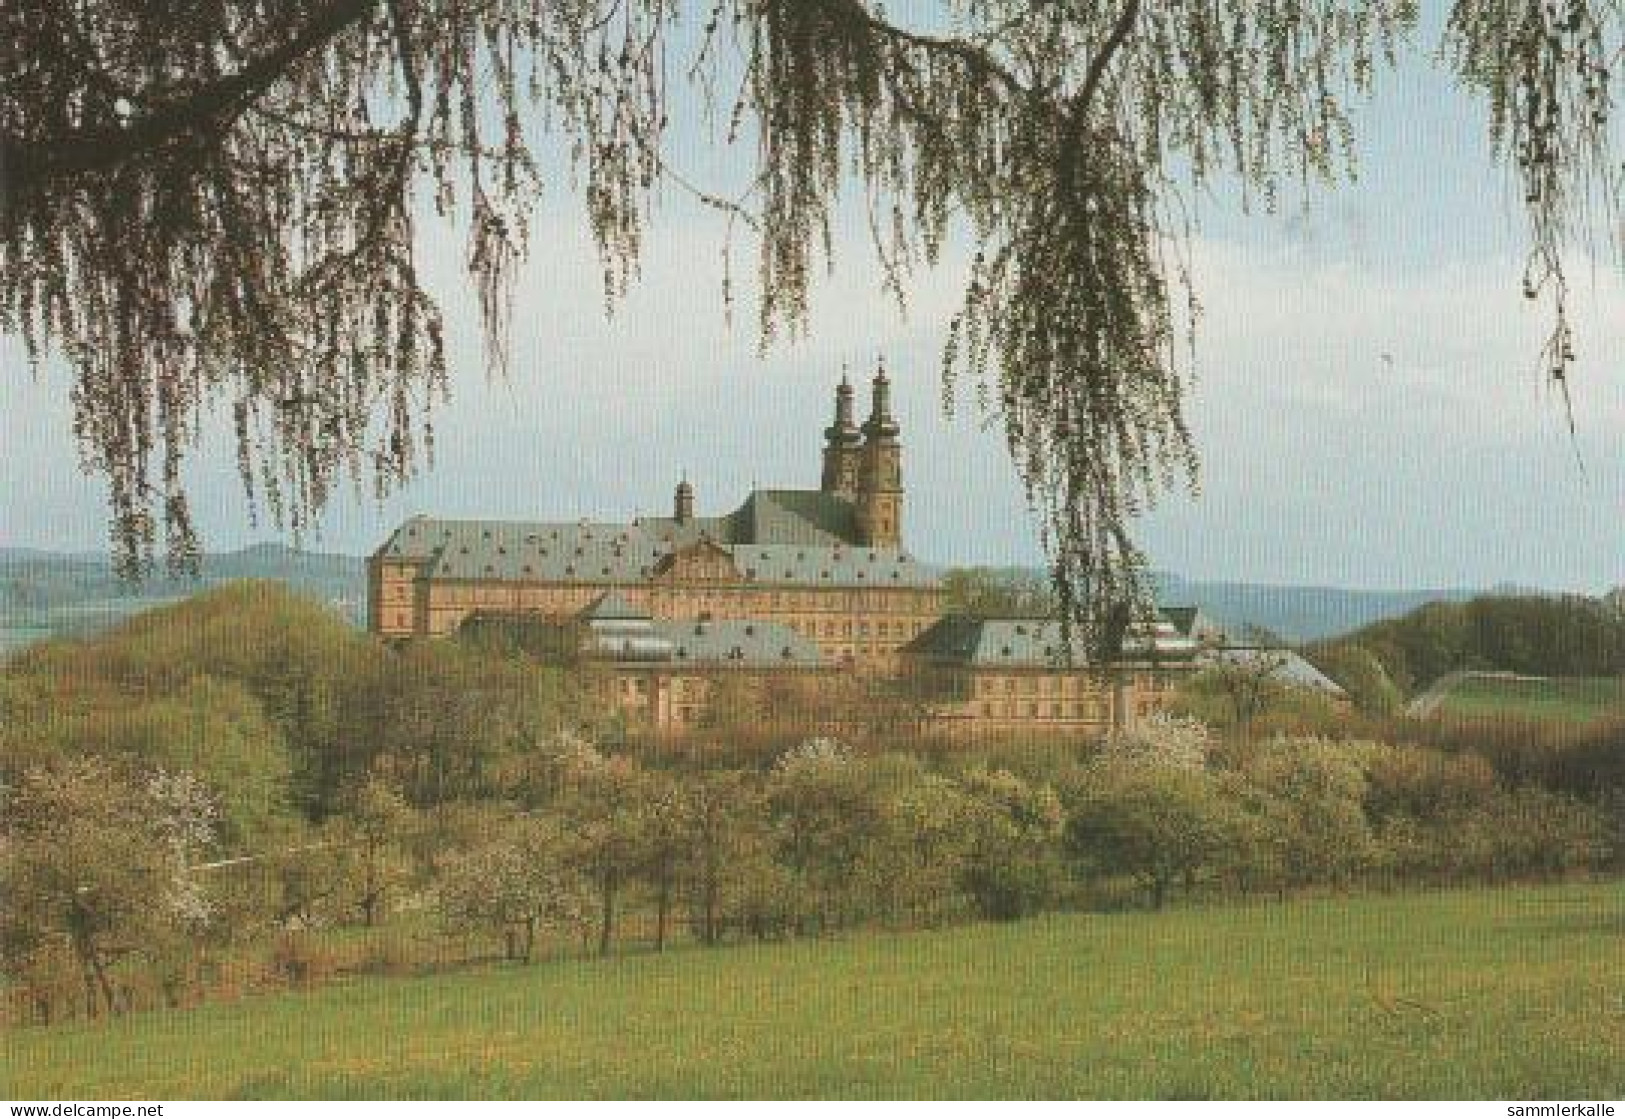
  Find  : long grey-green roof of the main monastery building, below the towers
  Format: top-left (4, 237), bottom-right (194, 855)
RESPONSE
top-left (375, 490), bottom-right (938, 588)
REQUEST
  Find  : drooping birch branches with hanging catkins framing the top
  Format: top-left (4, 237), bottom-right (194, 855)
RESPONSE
top-left (0, 0), bottom-right (1625, 638)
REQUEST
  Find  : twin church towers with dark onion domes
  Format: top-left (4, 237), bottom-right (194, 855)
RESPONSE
top-left (819, 365), bottom-right (904, 549)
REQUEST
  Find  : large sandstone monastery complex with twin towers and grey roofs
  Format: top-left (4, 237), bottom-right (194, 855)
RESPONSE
top-left (367, 369), bottom-right (1198, 734)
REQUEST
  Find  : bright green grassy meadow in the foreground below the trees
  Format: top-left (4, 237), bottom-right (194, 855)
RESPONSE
top-left (0, 884), bottom-right (1625, 1100)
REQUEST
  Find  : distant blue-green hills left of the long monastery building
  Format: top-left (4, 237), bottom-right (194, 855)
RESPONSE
top-left (0, 544), bottom-right (366, 653)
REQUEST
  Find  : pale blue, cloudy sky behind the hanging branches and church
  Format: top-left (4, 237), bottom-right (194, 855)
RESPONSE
top-left (0, 10), bottom-right (1625, 591)
